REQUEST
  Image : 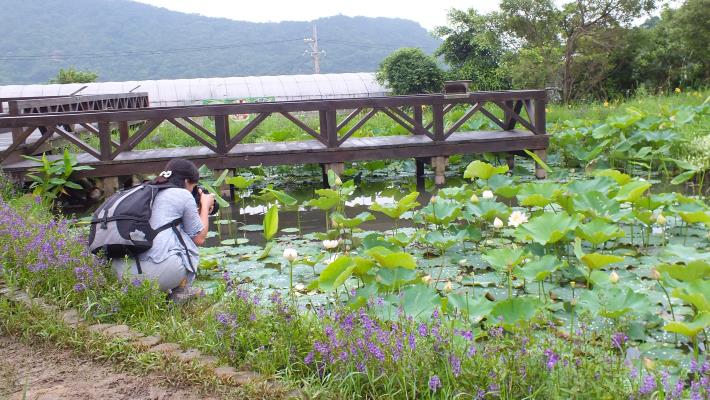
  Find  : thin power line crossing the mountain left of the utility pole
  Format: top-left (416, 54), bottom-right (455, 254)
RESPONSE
top-left (0, 39), bottom-right (301, 61)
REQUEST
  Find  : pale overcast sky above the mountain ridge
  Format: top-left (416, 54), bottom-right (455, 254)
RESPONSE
top-left (134, 0), bottom-right (499, 30)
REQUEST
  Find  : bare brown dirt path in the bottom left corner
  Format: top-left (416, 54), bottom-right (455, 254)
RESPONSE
top-left (0, 336), bottom-right (220, 400)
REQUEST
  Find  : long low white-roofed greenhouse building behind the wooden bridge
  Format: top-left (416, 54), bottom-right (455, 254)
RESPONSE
top-left (0, 73), bottom-right (386, 107)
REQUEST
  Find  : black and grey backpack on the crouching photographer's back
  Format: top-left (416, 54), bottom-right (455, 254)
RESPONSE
top-left (89, 183), bottom-right (195, 274)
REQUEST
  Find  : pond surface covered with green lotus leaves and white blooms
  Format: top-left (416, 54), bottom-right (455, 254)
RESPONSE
top-left (191, 157), bottom-right (710, 376)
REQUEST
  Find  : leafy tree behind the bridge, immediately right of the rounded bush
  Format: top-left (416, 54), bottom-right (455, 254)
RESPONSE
top-left (434, 9), bottom-right (510, 90)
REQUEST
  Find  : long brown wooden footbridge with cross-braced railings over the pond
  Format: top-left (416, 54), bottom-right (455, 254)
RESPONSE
top-left (0, 90), bottom-right (549, 188)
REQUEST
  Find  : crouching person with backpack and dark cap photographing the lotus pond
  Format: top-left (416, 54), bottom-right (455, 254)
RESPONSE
top-left (89, 159), bottom-right (216, 302)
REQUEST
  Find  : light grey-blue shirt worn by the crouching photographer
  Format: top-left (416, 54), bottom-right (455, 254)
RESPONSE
top-left (140, 188), bottom-right (203, 273)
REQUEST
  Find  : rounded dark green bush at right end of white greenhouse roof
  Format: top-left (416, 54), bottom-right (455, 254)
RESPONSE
top-left (376, 48), bottom-right (444, 95)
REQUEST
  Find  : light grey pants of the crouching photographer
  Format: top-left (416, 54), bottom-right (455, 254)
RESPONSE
top-left (111, 254), bottom-right (195, 293)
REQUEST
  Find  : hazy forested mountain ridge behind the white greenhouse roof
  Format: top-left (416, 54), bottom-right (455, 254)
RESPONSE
top-left (0, 0), bottom-right (439, 85)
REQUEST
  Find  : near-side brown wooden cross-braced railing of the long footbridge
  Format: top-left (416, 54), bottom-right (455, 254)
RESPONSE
top-left (0, 90), bottom-right (546, 161)
